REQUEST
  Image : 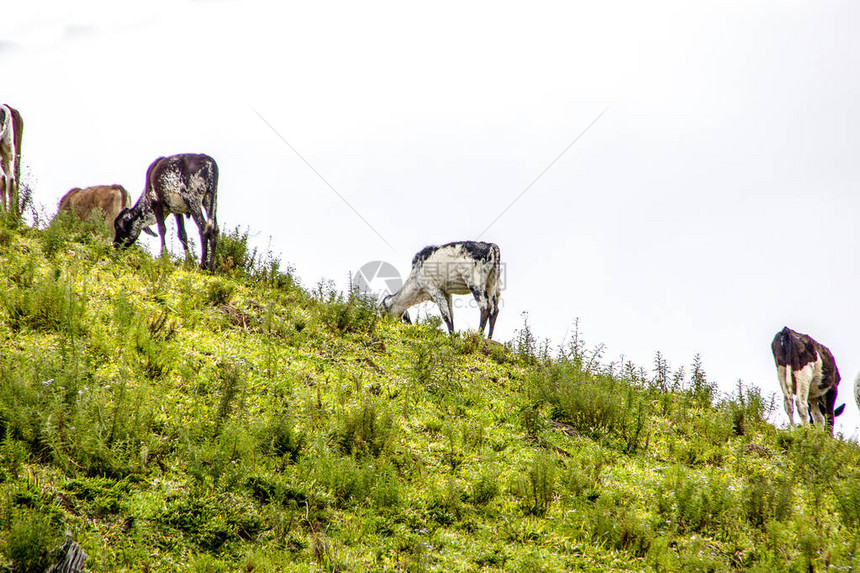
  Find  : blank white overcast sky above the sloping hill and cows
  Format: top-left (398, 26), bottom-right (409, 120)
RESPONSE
top-left (0, 0), bottom-right (860, 435)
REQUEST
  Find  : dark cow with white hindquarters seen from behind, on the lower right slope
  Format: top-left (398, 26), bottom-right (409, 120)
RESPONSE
top-left (771, 326), bottom-right (845, 433)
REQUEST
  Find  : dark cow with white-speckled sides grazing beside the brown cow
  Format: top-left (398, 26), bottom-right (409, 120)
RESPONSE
top-left (114, 153), bottom-right (218, 270)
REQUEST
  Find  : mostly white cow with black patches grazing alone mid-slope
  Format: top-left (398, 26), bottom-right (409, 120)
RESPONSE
top-left (382, 241), bottom-right (501, 338)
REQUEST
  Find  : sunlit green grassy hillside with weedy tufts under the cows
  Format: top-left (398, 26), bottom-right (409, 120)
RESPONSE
top-left (0, 216), bottom-right (860, 571)
